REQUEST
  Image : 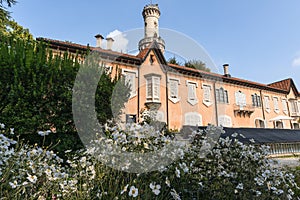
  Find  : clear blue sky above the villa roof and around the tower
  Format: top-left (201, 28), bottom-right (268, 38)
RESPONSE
top-left (9, 0), bottom-right (300, 90)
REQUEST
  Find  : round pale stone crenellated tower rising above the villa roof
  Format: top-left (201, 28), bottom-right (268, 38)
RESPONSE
top-left (139, 4), bottom-right (165, 52)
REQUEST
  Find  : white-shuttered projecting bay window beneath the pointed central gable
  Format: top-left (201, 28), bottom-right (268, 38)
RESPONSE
top-left (146, 75), bottom-right (160, 102)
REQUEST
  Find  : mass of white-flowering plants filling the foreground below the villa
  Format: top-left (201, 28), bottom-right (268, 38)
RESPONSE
top-left (0, 124), bottom-right (298, 200)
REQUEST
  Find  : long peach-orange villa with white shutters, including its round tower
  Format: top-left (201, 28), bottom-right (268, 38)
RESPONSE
top-left (37, 4), bottom-right (300, 130)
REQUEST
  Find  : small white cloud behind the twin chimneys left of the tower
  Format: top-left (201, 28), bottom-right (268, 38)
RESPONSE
top-left (103, 30), bottom-right (128, 53)
